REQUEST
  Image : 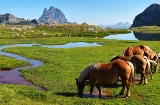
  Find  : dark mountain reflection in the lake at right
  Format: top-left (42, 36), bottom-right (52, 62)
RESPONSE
top-left (133, 32), bottom-right (160, 41)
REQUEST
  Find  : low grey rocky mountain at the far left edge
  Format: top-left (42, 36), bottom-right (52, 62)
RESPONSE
top-left (0, 13), bottom-right (25, 24)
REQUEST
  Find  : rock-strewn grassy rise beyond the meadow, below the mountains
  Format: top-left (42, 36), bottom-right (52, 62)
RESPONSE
top-left (0, 24), bottom-right (130, 39)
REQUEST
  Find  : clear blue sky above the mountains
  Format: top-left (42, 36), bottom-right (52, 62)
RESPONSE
top-left (0, 0), bottom-right (160, 25)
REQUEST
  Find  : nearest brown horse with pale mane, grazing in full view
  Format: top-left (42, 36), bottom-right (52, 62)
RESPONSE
top-left (76, 60), bottom-right (134, 98)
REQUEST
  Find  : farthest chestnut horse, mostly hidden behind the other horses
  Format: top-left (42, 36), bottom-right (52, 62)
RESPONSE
top-left (122, 45), bottom-right (152, 56)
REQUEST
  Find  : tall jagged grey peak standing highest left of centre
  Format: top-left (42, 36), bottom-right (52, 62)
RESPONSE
top-left (38, 6), bottom-right (68, 23)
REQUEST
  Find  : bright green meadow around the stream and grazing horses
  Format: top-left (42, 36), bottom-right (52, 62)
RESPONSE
top-left (0, 24), bottom-right (160, 105)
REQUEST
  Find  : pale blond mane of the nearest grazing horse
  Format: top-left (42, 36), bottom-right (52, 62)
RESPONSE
top-left (78, 63), bottom-right (100, 84)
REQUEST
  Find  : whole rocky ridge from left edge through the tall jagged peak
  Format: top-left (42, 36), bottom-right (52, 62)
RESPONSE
top-left (0, 6), bottom-right (68, 24)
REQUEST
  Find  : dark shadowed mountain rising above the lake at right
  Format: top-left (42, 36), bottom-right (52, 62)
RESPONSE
top-left (131, 3), bottom-right (160, 27)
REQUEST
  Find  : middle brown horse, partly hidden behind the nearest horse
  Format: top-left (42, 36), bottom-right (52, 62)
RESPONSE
top-left (110, 55), bottom-right (156, 85)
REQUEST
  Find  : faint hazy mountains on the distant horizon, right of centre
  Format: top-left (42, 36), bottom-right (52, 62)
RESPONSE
top-left (99, 22), bottom-right (131, 29)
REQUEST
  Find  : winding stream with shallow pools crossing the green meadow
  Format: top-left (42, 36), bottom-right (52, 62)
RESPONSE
top-left (0, 42), bottom-right (101, 91)
